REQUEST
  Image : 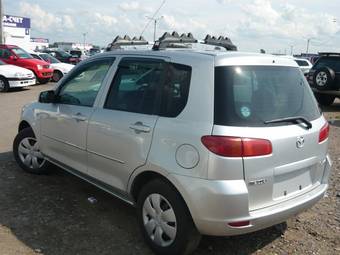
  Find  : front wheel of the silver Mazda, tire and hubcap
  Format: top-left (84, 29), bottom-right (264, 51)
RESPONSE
top-left (13, 127), bottom-right (50, 174)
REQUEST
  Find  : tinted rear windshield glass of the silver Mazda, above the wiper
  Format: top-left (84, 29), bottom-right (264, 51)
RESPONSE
top-left (214, 66), bottom-right (320, 127)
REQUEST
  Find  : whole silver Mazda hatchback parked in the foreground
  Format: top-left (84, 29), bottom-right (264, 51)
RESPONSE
top-left (13, 37), bottom-right (331, 254)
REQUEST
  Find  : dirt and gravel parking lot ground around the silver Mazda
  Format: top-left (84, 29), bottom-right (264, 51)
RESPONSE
top-left (0, 83), bottom-right (340, 255)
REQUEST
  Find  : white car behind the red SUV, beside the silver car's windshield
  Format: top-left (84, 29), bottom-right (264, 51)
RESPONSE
top-left (30, 52), bottom-right (74, 82)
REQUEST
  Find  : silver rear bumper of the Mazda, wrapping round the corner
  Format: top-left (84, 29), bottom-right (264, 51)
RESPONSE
top-left (172, 154), bottom-right (331, 236)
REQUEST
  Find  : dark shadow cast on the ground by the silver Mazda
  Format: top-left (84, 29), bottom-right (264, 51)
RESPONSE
top-left (0, 152), bottom-right (287, 255)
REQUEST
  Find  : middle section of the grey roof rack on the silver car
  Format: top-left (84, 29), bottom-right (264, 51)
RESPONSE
top-left (152, 31), bottom-right (198, 50)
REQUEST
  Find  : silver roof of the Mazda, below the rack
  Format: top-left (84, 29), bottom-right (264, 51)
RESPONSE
top-left (94, 49), bottom-right (298, 67)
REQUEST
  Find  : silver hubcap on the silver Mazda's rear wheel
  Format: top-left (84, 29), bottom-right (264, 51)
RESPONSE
top-left (143, 194), bottom-right (177, 247)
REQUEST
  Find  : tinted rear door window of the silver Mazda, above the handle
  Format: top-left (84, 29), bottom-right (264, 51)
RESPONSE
top-left (105, 59), bottom-right (165, 114)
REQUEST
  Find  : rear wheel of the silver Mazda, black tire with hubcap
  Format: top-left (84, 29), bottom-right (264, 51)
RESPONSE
top-left (137, 179), bottom-right (201, 255)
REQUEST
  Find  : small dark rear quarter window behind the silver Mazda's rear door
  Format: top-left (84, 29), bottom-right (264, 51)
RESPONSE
top-left (161, 64), bottom-right (191, 117)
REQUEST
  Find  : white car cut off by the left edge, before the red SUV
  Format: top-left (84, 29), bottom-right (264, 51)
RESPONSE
top-left (0, 61), bottom-right (36, 92)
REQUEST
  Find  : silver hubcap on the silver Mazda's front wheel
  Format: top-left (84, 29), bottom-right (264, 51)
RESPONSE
top-left (18, 137), bottom-right (45, 169)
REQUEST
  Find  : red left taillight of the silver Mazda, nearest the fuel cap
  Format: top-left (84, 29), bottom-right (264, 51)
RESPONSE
top-left (201, 135), bottom-right (273, 157)
